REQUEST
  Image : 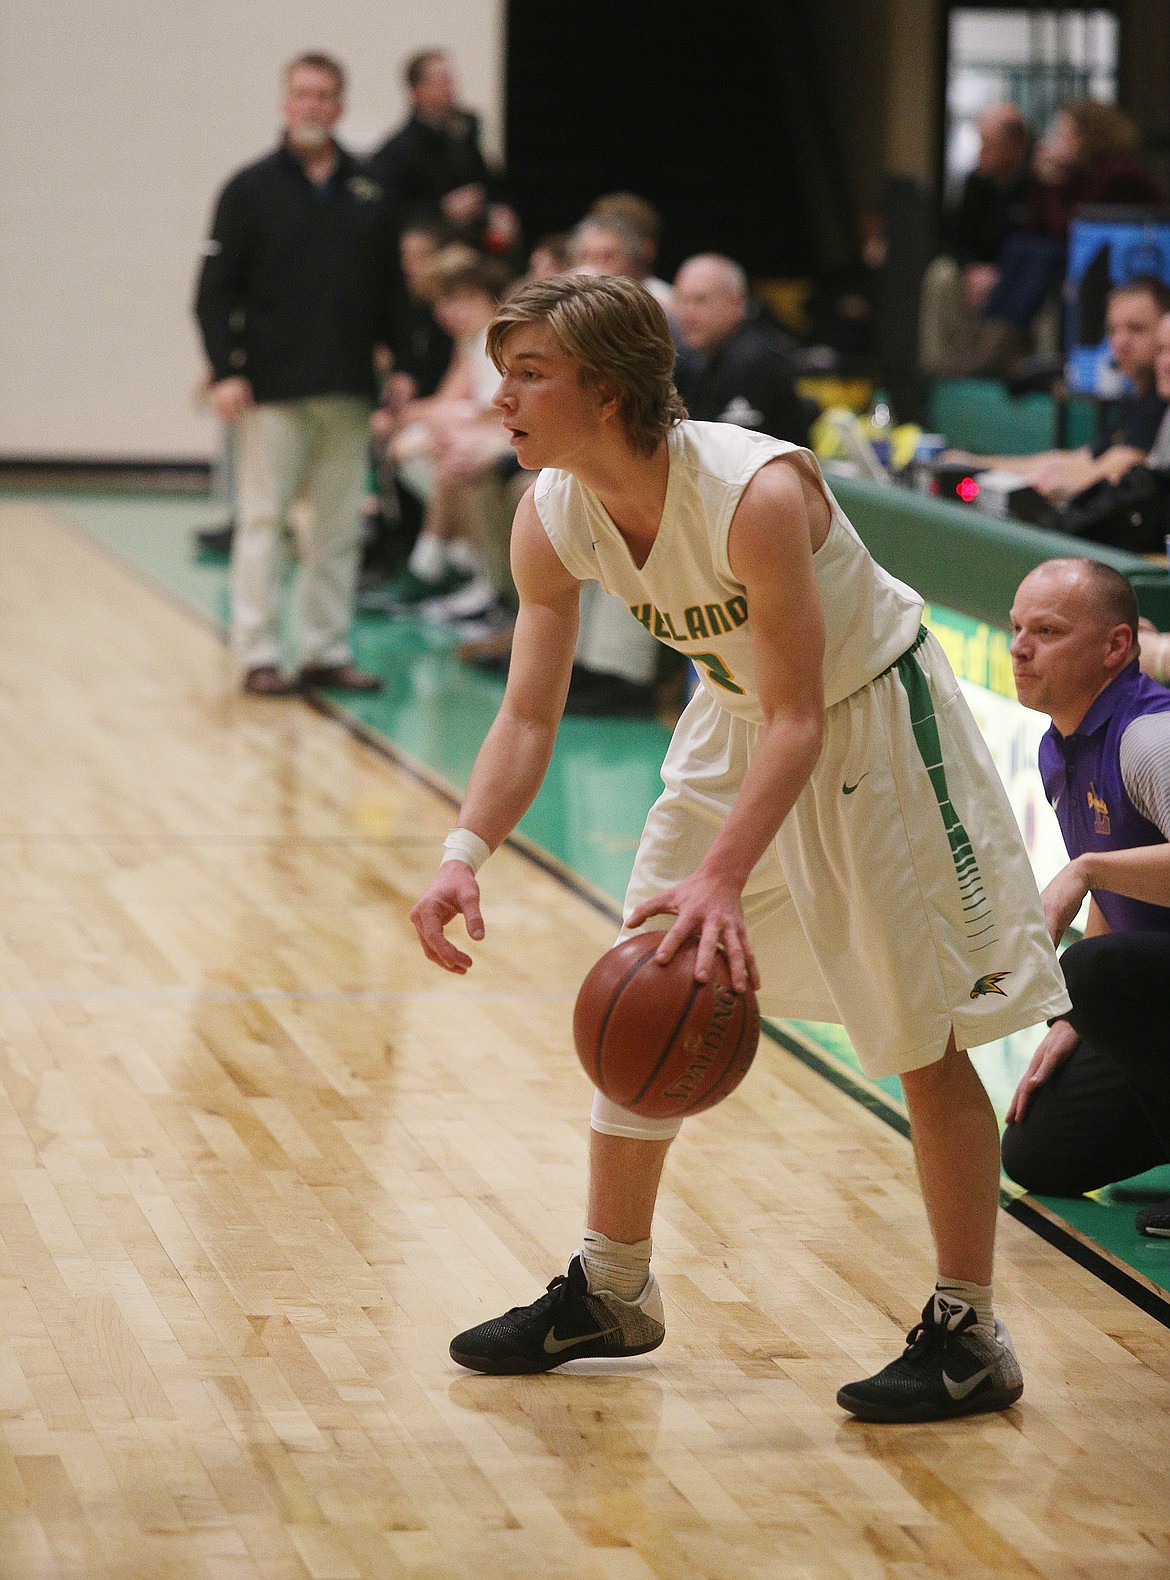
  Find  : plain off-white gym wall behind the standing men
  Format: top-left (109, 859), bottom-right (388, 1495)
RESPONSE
top-left (0, 0), bottom-right (504, 458)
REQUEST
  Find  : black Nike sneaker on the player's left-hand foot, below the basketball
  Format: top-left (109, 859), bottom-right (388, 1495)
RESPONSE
top-left (452, 1255), bottom-right (666, 1376)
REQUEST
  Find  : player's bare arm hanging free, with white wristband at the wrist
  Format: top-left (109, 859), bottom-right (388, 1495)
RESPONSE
top-left (411, 493), bottom-right (581, 975)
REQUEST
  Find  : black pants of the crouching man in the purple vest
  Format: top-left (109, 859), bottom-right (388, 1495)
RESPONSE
top-left (1003, 932), bottom-right (1170, 1196)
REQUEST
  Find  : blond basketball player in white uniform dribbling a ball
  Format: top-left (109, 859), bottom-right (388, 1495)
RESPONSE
top-left (412, 277), bottom-right (1069, 1420)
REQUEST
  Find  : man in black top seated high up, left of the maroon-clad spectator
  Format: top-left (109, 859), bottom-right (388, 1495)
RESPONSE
top-left (919, 104), bottom-right (1029, 373)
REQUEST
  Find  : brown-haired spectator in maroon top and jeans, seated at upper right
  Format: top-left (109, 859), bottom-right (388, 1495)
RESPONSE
top-left (936, 100), bottom-right (1162, 374)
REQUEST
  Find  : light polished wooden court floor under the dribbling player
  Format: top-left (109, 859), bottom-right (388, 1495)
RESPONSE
top-left (0, 506), bottom-right (1170, 1580)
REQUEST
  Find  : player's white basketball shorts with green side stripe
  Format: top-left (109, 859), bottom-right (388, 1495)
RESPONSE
top-left (594, 632), bottom-right (1069, 1136)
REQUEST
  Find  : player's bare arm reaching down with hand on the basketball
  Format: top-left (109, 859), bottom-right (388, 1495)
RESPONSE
top-left (628, 458), bottom-right (831, 992)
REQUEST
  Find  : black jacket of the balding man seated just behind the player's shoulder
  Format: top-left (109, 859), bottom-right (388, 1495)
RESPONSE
top-left (674, 316), bottom-right (816, 444)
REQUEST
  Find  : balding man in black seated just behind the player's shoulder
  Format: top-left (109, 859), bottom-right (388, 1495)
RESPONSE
top-left (674, 253), bottom-right (816, 444)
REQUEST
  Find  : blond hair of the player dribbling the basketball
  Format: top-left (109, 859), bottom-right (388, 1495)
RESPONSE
top-left (488, 275), bottom-right (687, 455)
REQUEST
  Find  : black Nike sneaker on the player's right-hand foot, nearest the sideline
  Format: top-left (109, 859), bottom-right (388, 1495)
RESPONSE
top-left (837, 1294), bottom-right (1023, 1420)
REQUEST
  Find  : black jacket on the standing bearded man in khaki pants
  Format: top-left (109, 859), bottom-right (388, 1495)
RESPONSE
top-left (196, 144), bottom-right (403, 401)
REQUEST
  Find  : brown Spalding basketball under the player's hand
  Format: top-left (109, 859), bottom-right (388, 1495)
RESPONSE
top-left (573, 932), bottom-right (759, 1119)
